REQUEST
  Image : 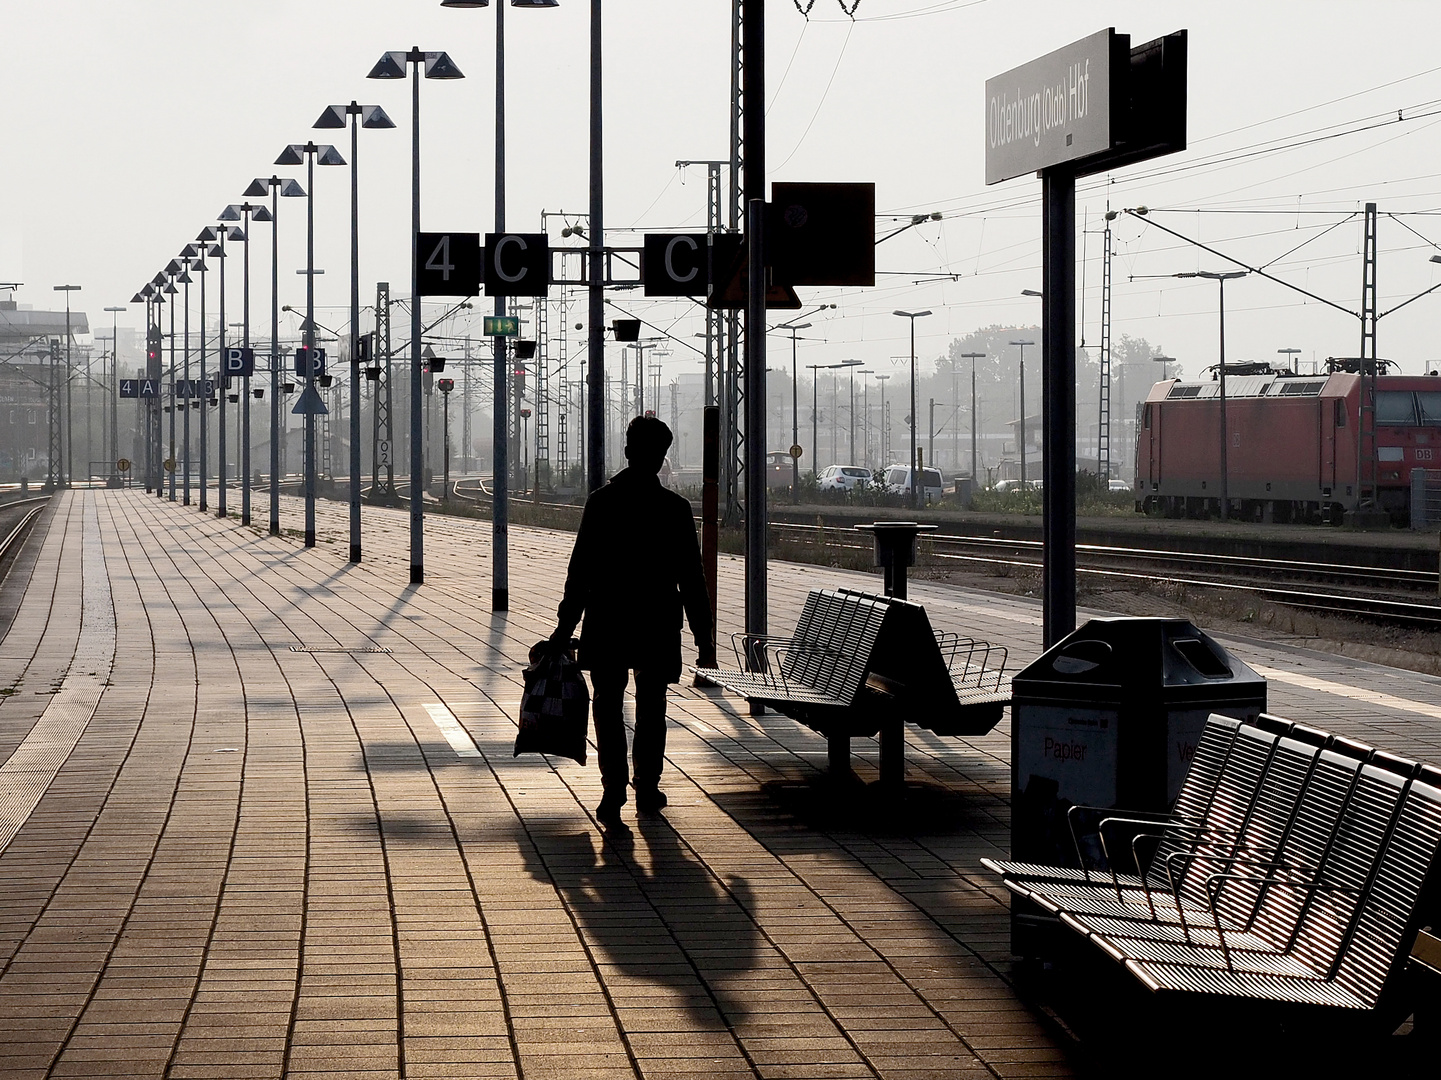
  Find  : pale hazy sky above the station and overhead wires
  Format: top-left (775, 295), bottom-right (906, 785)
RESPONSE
top-left (0, 0), bottom-right (1441, 383)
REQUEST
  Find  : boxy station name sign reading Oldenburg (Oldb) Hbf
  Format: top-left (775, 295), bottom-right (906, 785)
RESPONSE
top-left (986, 27), bottom-right (1186, 183)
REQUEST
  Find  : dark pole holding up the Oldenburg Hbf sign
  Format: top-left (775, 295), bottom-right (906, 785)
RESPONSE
top-left (1040, 167), bottom-right (1076, 649)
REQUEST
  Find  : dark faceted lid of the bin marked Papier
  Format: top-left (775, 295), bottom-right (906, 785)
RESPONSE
top-left (1013, 617), bottom-right (1265, 704)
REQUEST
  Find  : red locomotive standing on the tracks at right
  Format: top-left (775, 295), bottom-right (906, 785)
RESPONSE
top-left (1136, 360), bottom-right (1441, 525)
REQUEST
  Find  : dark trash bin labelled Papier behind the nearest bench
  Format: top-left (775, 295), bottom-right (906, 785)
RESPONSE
top-left (1010, 619), bottom-right (1265, 865)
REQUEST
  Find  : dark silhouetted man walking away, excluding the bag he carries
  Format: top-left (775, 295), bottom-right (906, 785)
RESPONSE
top-left (550, 417), bottom-right (716, 823)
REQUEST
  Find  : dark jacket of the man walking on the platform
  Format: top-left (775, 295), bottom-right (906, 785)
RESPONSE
top-left (556, 469), bottom-right (710, 682)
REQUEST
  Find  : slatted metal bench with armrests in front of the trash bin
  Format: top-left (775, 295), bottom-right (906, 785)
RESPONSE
top-left (983, 715), bottom-right (1441, 1027)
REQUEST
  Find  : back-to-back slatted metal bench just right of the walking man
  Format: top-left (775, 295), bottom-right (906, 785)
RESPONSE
top-left (696, 588), bottom-right (1010, 783)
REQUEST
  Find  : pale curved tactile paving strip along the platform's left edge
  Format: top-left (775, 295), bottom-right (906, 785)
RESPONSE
top-left (0, 500), bottom-right (115, 851)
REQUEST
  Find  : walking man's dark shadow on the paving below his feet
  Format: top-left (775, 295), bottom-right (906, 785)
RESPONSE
top-left (516, 818), bottom-right (759, 1031)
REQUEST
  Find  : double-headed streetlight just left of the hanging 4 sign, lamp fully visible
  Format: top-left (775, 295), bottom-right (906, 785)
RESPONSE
top-left (366, 44), bottom-right (464, 582)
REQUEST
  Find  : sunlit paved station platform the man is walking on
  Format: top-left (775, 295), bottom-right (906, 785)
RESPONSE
top-left (0, 490), bottom-right (1441, 1080)
